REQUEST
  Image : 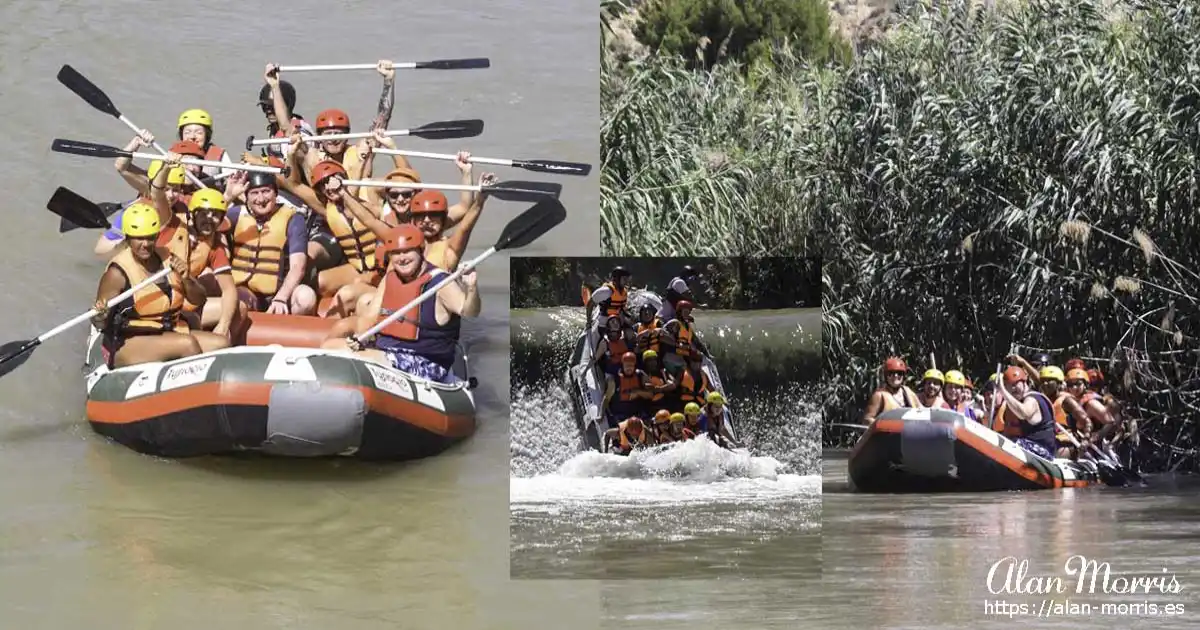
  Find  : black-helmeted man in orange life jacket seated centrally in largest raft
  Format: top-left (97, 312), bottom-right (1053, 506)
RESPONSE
top-left (226, 172), bottom-right (317, 314)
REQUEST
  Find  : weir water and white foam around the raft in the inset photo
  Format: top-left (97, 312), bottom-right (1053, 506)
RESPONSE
top-left (511, 302), bottom-right (821, 578)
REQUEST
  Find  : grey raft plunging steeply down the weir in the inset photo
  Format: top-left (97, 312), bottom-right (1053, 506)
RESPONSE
top-left (563, 290), bottom-right (738, 450)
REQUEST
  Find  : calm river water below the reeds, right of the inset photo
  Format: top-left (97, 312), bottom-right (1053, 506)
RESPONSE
top-left (820, 450), bottom-right (1200, 629)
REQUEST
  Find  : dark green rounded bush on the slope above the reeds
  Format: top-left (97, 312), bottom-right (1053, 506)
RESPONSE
top-left (635, 0), bottom-right (848, 70)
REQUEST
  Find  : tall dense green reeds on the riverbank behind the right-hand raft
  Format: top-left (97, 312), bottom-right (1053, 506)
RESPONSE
top-left (602, 0), bottom-right (1200, 469)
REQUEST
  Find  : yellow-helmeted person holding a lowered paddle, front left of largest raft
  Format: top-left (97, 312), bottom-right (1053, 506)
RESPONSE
top-left (92, 203), bottom-right (229, 367)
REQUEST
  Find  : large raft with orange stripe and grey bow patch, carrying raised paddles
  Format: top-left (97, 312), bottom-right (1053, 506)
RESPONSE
top-left (84, 313), bottom-right (475, 460)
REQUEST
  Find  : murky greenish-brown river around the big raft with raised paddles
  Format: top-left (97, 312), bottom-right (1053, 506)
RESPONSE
top-left (0, 0), bottom-right (600, 630)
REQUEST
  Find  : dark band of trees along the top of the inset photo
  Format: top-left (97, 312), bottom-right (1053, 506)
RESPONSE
top-left (510, 258), bottom-right (821, 311)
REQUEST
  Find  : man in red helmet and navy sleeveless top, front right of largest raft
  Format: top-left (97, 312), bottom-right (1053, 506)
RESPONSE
top-left (325, 226), bottom-right (481, 383)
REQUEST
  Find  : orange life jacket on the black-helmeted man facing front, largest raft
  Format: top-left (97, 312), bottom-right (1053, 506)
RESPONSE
top-left (229, 205), bottom-right (295, 296)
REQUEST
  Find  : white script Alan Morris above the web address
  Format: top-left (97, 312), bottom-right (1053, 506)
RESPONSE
top-left (988, 556), bottom-right (1183, 595)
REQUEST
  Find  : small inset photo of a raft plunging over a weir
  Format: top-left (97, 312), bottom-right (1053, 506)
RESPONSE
top-left (510, 258), bottom-right (822, 580)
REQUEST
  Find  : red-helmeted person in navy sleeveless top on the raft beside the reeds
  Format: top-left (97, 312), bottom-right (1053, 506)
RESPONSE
top-left (994, 365), bottom-right (1057, 460)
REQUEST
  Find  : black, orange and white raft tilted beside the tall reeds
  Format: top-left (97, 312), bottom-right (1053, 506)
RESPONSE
top-left (848, 408), bottom-right (1100, 492)
